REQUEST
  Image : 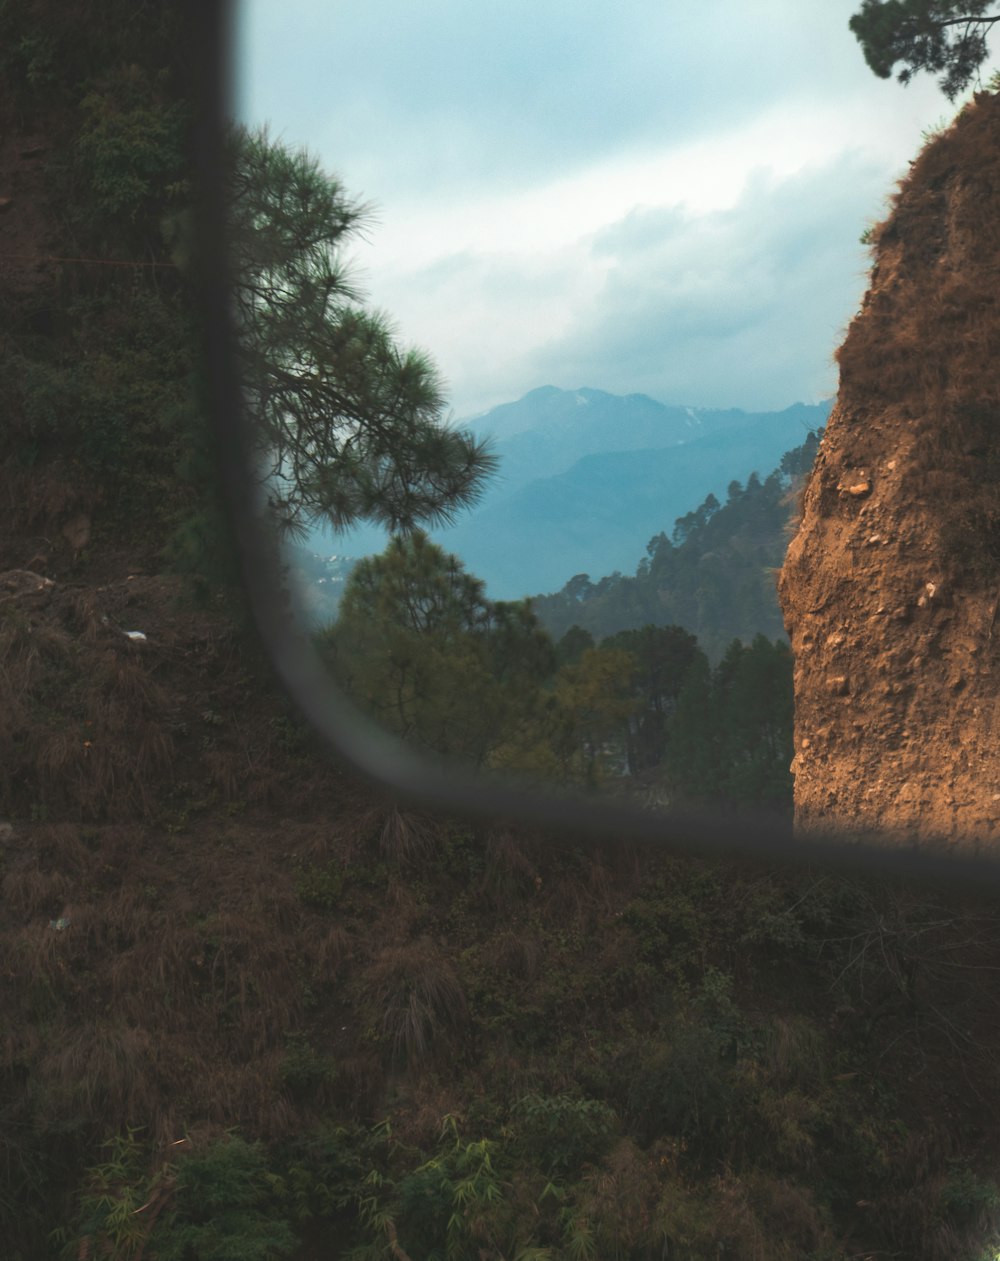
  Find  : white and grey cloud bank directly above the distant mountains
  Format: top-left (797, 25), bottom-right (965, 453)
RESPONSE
top-left (350, 154), bottom-right (884, 415)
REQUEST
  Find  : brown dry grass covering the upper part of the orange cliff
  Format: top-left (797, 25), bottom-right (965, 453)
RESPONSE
top-left (836, 95), bottom-right (1000, 589)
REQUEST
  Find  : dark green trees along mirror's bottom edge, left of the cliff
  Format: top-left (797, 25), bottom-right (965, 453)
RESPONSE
top-left (317, 522), bottom-right (798, 812)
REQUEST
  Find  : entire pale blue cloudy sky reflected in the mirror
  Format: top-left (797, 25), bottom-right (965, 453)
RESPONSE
top-left (235, 0), bottom-right (989, 420)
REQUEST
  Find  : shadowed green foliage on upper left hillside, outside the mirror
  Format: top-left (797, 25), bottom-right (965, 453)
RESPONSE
top-left (0, 0), bottom-right (226, 570)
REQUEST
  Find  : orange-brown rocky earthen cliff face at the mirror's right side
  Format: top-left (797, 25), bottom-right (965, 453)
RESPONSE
top-left (779, 93), bottom-right (1000, 846)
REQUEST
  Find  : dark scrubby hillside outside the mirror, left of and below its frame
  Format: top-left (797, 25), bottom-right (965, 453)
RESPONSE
top-left (0, 9), bottom-right (1000, 1261)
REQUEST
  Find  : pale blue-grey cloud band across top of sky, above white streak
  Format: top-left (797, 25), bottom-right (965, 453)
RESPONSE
top-left (238, 0), bottom-right (938, 204)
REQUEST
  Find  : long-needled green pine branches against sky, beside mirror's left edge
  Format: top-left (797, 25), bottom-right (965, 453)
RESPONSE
top-left (228, 127), bottom-right (496, 533)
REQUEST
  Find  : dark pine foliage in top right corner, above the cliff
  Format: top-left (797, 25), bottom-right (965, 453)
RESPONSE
top-left (849, 0), bottom-right (1000, 101)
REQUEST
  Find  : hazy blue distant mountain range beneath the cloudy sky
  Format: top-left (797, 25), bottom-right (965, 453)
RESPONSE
top-left (300, 386), bottom-right (831, 599)
